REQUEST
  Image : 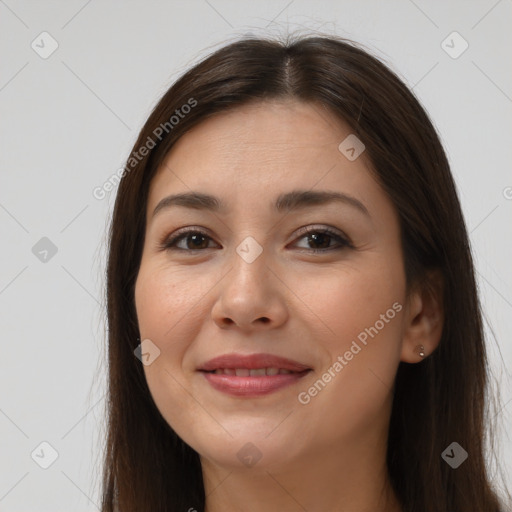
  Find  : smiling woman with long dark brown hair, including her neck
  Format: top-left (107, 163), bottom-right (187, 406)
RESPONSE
top-left (103, 37), bottom-right (504, 512)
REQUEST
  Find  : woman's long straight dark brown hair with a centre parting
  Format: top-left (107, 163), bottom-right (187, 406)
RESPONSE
top-left (102, 36), bottom-right (504, 512)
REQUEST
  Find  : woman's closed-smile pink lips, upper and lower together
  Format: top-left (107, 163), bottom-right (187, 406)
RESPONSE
top-left (198, 354), bottom-right (312, 398)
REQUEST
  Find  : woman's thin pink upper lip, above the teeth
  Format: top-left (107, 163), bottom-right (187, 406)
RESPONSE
top-left (198, 354), bottom-right (311, 372)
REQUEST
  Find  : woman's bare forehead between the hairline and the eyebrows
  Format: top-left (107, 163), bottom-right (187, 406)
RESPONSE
top-left (148, 100), bottom-right (382, 216)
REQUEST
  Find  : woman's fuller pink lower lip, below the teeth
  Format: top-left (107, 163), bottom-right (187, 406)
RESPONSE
top-left (201, 370), bottom-right (310, 397)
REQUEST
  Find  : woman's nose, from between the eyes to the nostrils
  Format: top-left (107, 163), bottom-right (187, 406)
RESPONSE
top-left (212, 243), bottom-right (290, 332)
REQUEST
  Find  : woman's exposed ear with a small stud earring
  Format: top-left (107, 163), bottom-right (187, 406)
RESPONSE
top-left (400, 269), bottom-right (444, 363)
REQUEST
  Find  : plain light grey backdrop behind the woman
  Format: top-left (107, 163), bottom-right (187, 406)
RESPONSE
top-left (0, 0), bottom-right (512, 512)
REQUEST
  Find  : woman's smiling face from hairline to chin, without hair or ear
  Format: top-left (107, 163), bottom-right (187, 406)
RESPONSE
top-left (135, 101), bottom-right (406, 467)
